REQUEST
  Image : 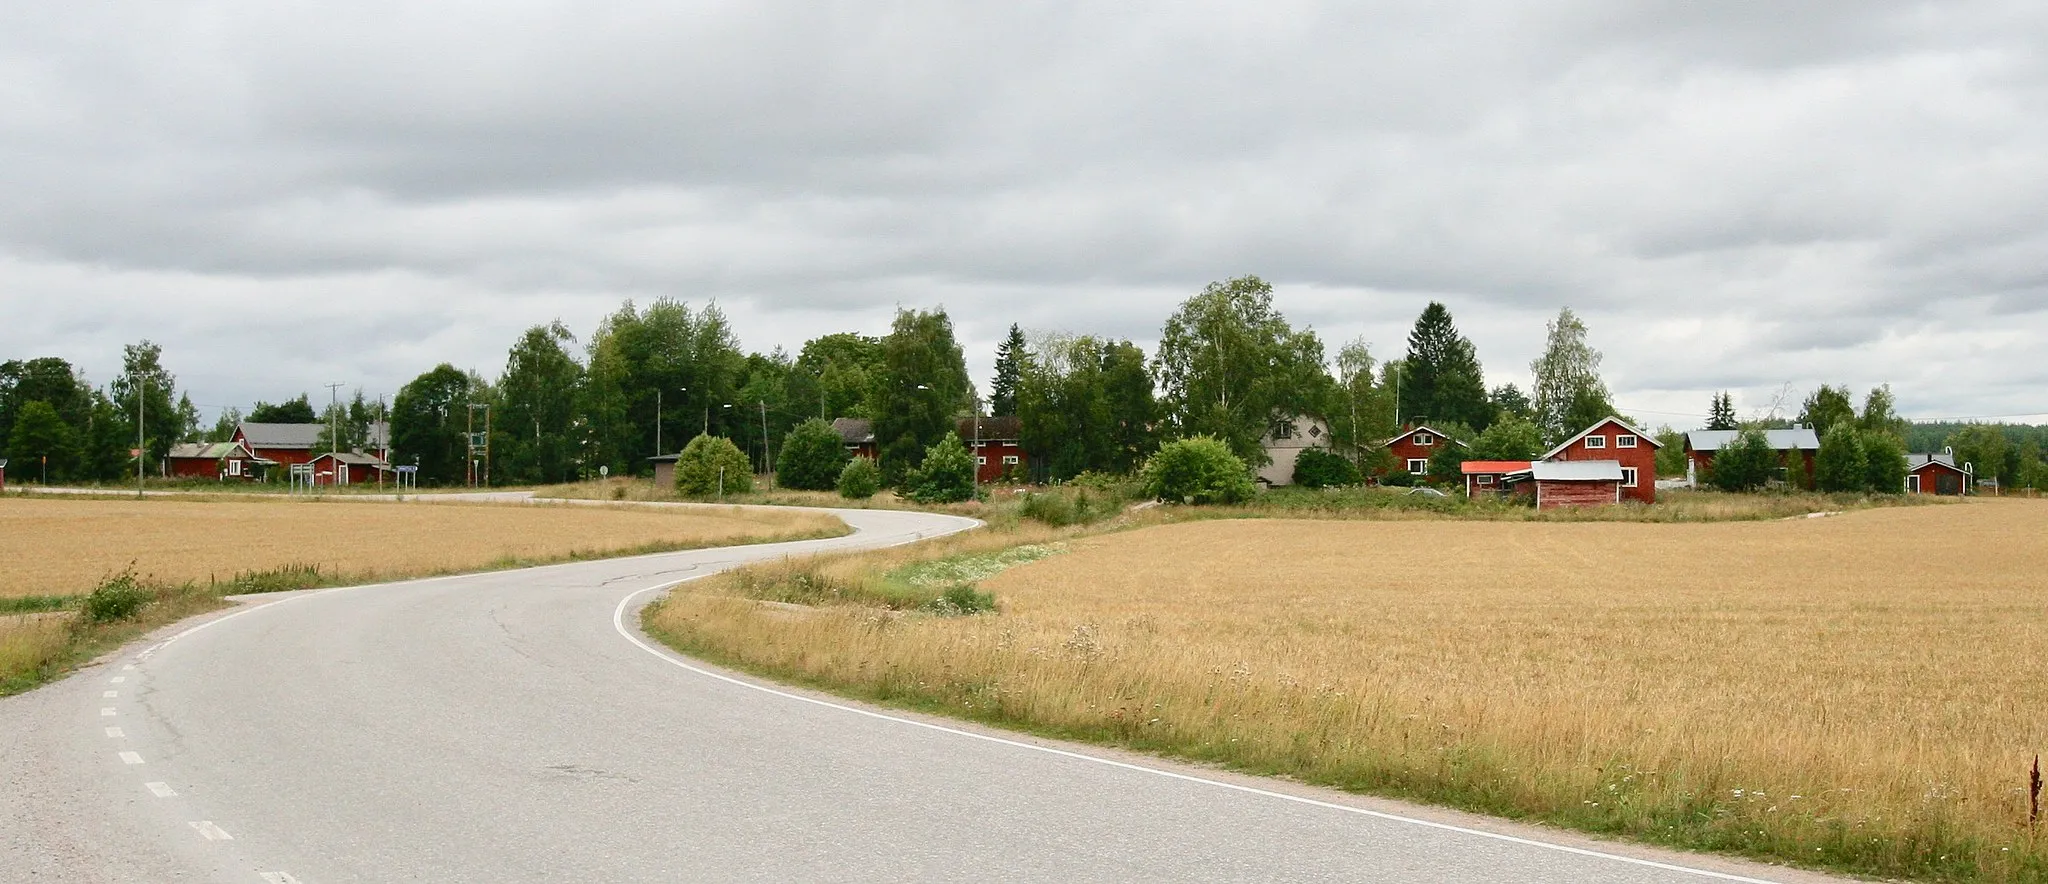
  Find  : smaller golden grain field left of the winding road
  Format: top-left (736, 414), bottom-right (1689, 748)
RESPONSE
top-left (0, 497), bottom-right (844, 598)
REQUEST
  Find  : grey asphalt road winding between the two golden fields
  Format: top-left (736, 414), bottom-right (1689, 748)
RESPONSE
top-left (0, 510), bottom-right (1821, 884)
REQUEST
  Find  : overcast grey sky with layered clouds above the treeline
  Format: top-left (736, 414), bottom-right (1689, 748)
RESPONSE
top-left (0, 0), bottom-right (2048, 428)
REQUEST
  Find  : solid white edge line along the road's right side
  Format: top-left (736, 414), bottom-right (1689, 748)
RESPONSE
top-left (612, 575), bottom-right (1776, 884)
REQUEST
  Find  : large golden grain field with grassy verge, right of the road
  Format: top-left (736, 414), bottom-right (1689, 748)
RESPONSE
top-left (649, 501), bottom-right (2048, 880)
